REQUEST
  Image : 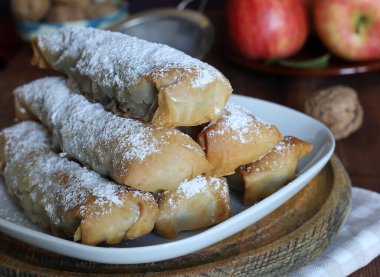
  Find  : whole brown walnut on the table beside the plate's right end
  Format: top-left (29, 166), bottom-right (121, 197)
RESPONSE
top-left (305, 86), bottom-right (363, 140)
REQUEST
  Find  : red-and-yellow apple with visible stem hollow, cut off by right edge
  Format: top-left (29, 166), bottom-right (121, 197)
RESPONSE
top-left (313, 0), bottom-right (380, 61)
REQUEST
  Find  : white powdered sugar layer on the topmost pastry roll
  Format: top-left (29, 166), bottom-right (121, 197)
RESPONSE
top-left (38, 27), bottom-right (226, 91)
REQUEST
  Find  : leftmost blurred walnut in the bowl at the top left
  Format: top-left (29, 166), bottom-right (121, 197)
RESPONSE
top-left (11, 0), bottom-right (51, 21)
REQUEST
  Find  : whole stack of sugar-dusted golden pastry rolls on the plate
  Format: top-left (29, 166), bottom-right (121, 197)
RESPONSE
top-left (0, 25), bottom-right (311, 245)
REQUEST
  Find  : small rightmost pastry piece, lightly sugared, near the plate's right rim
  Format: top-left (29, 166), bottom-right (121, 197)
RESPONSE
top-left (235, 136), bottom-right (313, 205)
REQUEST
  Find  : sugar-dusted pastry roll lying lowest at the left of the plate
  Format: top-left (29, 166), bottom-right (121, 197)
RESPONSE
top-left (0, 121), bottom-right (159, 245)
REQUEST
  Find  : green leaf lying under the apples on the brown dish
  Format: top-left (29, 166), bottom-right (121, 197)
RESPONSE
top-left (266, 54), bottom-right (331, 69)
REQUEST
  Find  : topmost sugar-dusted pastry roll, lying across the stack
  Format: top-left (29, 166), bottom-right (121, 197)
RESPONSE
top-left (32, 27), bottom-right (232, 126)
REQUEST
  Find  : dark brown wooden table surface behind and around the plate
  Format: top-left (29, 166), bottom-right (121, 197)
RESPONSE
top-left (0, 14), bottom-right (380, 276)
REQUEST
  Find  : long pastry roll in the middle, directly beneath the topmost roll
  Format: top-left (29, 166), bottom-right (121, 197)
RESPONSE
top-left (14, 77), bottom-right (211, 192)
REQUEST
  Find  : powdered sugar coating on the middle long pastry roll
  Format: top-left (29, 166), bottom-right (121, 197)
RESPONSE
top-left (15, 77), bottom-right (200, 177)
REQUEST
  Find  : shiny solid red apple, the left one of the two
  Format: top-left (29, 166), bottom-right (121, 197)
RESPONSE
top-left (226, 0), bottom-right (308, 59)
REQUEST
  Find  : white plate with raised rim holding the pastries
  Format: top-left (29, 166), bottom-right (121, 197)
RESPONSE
top-left (0, 95), bottom-right (335, 264)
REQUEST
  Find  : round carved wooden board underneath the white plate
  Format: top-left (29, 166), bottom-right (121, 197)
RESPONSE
top-left (0, 156), bottom-right (351, 276)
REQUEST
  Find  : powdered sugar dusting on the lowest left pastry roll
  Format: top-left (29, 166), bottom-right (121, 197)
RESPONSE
top-left (2, 121), bottom-right (154, 229)
